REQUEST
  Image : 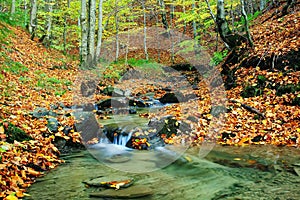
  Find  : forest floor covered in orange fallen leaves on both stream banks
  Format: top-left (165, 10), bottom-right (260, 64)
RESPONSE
top-left (0, 1), bottom-right (300, 199)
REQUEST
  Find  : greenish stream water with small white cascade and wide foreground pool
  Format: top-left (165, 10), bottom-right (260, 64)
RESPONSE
top-left (26, 96), bottom-right (300, 200)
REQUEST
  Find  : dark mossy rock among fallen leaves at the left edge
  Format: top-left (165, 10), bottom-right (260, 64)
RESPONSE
top-left (0, 122), bottom-right (32, 143)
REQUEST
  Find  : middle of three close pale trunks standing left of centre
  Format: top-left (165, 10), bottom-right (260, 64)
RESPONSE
top-left (88, 0), bottom-right (96, 67)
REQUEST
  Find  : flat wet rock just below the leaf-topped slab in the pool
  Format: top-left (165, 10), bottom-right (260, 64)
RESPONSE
top-left (90, 185), bottom-right (153, 199)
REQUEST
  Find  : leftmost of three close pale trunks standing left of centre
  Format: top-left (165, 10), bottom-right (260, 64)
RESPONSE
top-left (80, 0), bottom-right (88, 69)
